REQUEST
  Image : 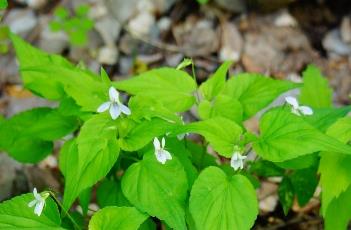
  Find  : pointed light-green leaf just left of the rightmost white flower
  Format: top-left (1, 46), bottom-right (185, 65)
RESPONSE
top-left (223, 73), bottom-right (299, 119)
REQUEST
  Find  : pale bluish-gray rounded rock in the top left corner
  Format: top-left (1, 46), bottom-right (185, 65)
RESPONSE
top-left (5, 9), bottom-right (38, 37)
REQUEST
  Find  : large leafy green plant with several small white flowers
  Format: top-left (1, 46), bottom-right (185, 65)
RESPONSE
top-left (0, 35), bottom-right (351, 229)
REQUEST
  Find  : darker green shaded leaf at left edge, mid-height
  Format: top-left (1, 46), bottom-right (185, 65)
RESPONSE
top-left (0, 108), bottom-right (78, 163)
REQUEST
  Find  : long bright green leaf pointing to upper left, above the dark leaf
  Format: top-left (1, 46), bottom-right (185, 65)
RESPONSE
top-left (11, 35), bottom-right (109, 111)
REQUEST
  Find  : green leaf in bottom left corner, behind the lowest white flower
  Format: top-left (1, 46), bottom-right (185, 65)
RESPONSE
top-left (0, 193), bottom-right (63, 230)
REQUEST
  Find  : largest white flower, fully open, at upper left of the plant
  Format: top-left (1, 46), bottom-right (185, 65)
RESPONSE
top-left (97, 86), bottom-right (131, 120)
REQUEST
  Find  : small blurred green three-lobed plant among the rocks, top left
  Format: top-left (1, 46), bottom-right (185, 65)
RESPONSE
top-left (50, 5), bottom-right (94, 46)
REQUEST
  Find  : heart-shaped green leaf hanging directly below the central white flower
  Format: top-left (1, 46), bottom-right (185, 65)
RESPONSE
top-left (122, 152), bottom-right (188, 229)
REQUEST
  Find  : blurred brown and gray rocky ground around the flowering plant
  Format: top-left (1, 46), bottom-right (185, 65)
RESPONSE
top-left (0, 0), bottom-right (351, 229)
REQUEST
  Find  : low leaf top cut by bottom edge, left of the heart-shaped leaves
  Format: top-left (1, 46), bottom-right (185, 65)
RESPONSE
top-left (89, 206), bottom-right (148, 230)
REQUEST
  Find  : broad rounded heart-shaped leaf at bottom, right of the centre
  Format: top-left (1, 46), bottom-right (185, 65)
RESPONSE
top-left (189, 166), bottom-right (258, 230)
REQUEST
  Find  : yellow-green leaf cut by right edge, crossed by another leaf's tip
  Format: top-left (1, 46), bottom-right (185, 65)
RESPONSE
top-left (319, 117), bottom-right (351, 229)
